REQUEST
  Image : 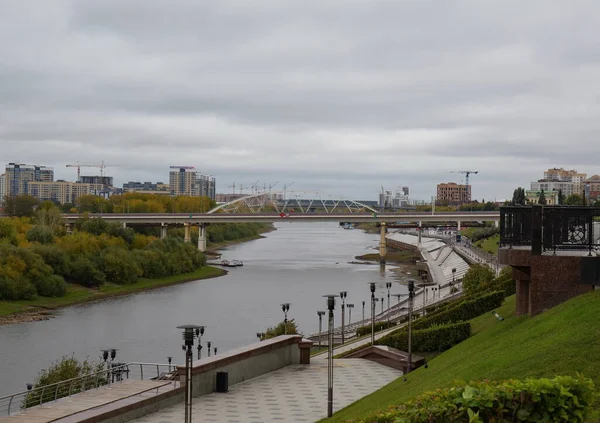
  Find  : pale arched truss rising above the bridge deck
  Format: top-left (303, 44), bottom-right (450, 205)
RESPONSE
top-left (207, 191), bottom-right (377, 214)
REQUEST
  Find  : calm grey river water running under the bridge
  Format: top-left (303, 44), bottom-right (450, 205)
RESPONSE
top-left (0, 222), bottom-right (406, 396)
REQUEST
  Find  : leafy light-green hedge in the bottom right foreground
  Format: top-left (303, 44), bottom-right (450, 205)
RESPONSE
top-left (354, 376), bottom-right (594, 423)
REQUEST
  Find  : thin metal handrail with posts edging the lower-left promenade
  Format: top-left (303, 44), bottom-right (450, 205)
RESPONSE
top-left (0, 362), bottom-right (177, 415)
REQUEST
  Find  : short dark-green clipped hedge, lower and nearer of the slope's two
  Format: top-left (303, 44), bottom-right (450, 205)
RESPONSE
top-left (377, 322), bottom-right (471, 352)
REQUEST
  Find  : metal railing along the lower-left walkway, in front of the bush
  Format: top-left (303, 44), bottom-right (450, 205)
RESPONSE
top-left (0, 362), bottom-right (177, 416)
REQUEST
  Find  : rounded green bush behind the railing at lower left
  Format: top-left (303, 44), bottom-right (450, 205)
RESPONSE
top-left (23, 356), bottom-right (108, 408)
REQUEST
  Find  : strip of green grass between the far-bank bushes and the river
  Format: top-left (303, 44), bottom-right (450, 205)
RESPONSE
top-left (0, 266), bottom-right (226, 316)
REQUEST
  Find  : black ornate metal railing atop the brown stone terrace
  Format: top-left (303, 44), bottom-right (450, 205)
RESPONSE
top-left (500, 206), bottom-right (600, 254)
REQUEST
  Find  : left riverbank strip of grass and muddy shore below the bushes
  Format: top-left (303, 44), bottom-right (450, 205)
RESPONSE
top-left (0, 266), bottom-right (227, 325)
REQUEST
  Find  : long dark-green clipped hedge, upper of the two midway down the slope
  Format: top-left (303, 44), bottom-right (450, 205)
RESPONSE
top-left (413, 291), bottom-right (504, 330)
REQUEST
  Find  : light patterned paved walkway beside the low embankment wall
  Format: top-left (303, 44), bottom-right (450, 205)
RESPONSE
top-left (134, 359), bottom-right (402, 423)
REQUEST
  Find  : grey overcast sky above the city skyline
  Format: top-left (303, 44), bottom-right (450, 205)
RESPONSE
top-left (0, 0), bottom-right (600, 200)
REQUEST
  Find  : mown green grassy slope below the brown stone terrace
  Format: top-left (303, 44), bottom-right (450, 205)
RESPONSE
top-left (324, 291), bottom-right (600, 422)
